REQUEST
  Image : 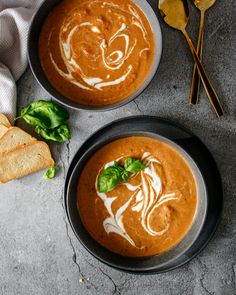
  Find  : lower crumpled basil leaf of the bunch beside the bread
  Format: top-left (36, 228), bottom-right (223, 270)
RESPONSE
top-left (35, 124), bottom-right (71, 143)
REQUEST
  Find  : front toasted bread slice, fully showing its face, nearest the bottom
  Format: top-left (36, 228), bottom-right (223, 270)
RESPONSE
top-left (0, 141), bottom-right (54, 183)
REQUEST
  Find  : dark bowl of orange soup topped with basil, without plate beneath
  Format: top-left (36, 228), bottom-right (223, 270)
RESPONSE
top-left (66, 119), bottom-right (207, 272)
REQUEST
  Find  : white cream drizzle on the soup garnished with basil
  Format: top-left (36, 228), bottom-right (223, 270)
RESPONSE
top-left (95, 152), bottom-right (179, 248)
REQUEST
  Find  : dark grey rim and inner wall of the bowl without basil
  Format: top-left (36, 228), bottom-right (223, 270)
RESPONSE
top-left (27, 0), bottom-right (163, 112)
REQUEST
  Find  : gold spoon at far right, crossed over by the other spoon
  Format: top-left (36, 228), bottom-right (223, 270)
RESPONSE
top-left (189, 0), bottom-right (216, 104)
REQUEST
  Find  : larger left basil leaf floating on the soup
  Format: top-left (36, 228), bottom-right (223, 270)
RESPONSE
top-left (98, 165), bottom-right (122, 193)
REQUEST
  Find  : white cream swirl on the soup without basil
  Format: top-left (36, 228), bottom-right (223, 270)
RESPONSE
top-left (48, 0), bottom-right (150, 91)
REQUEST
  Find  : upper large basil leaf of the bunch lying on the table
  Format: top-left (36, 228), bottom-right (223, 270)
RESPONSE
top-left (16, 100), bottom-right (69, 129)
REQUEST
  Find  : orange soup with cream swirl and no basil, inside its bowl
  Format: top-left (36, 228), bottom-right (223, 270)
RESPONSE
top-left (39, 0), bottom-right (155, 105)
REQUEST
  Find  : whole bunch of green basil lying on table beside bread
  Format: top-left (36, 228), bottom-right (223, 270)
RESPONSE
top-left (16, 100), bottom-right (71, 143)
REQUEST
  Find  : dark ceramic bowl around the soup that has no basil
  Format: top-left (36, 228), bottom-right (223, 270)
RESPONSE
top-left (28, 0), bottom-right (162, 111)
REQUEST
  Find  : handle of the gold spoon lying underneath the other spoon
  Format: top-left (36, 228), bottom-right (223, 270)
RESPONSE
top-left (189, 12), bottom-right (205, 105)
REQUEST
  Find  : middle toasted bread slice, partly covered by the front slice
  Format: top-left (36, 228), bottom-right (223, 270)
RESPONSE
top-left (0, 127), bottom-right (36, 155)
